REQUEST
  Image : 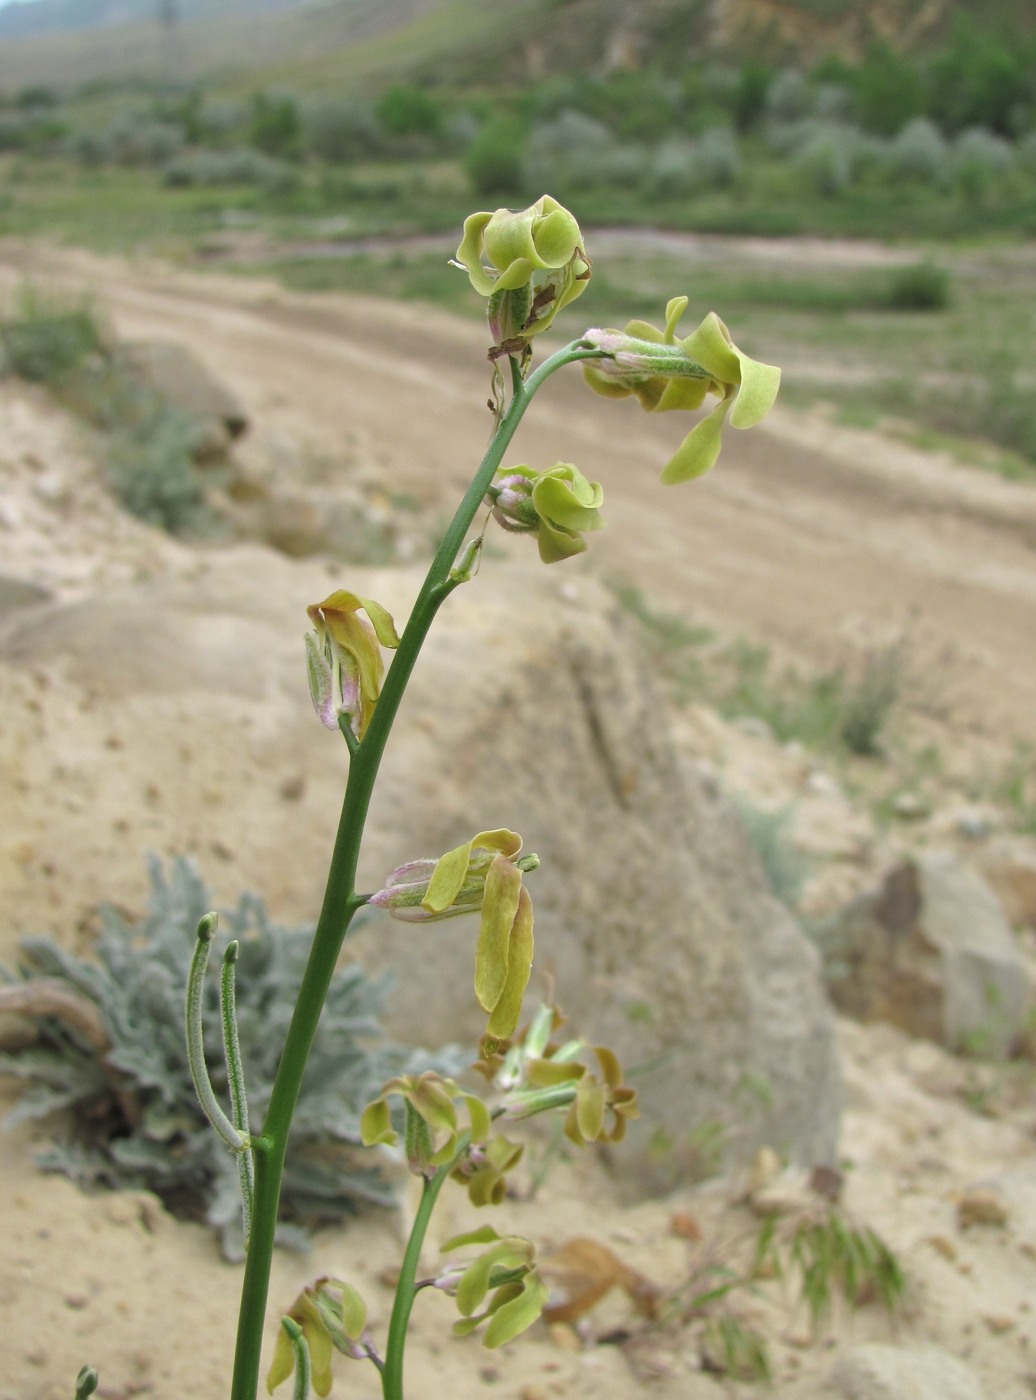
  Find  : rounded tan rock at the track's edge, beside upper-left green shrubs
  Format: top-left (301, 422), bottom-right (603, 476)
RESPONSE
top-left (115, 340), bottom-right (248, 458)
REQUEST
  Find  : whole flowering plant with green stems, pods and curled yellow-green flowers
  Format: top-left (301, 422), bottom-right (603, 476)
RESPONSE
top-left (83, 195), bottom-right (778, 1400)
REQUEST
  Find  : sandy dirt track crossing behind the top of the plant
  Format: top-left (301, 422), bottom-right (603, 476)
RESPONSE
top-left (8, 249), bottom-right (1036, 761)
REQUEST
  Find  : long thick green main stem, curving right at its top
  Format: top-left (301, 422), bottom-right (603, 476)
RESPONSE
top-left (231, 342), bottom-right (599, 1400)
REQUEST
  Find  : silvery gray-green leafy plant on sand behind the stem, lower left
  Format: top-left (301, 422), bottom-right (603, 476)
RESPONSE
top-left (0, 858), bottom-right (431, 1256)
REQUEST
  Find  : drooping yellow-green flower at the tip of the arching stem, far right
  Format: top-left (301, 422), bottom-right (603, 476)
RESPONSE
top-left (582, 297), bottom-right (781, 484)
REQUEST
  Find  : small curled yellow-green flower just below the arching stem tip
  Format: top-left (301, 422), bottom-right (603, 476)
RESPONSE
top-left (486, 462), bottom-right (605, 564)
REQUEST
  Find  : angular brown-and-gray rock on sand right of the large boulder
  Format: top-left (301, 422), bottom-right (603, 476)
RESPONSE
top-left (820, 851), bottom-right (1029, 1057)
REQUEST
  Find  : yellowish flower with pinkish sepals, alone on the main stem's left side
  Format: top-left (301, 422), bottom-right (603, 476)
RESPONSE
top-left (305, 588), bottom-right (399, 739)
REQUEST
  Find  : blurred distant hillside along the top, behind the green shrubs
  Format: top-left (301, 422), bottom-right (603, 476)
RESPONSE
top-left (0, 0), bottom-right (1036, 94)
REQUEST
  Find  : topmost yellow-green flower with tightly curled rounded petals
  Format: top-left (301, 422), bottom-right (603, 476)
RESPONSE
top-left (455, 195), bottom-right (589, 353)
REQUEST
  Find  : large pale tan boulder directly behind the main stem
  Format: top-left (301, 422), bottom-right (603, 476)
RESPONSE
top-left (0, 547), bottom-right (839, 1187)
